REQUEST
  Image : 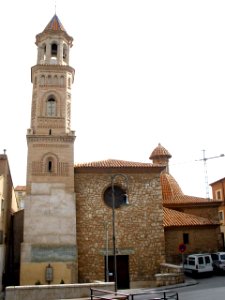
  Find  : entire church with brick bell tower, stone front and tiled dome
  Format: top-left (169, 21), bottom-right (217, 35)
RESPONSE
top-left (14, 15), bottom-right (220, 289)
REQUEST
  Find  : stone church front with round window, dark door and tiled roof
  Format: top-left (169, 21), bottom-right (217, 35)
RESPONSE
top-left (75, 160), bottom-right (165, 289)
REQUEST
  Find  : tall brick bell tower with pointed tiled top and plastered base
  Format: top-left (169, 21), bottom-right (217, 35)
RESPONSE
top-left (20, 15), bottom-right (78, 285)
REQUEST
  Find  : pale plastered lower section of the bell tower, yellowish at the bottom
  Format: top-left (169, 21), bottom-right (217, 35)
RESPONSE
top-left (20, 183), bottom-right (78, 285)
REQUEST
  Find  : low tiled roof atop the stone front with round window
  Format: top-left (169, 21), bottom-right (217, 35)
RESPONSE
top-left (74, 159), bottom-right (162, 169)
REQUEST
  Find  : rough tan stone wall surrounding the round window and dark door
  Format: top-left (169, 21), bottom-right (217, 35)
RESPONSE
top-left (75, 170), bottom-right (165, 288)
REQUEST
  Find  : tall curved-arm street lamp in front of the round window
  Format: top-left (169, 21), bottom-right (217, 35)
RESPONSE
top-left (111, 174), bottom-right (128, 293)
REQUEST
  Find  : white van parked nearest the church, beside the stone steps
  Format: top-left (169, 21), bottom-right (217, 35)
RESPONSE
top-left (183, 253), bottom-right (213, 275)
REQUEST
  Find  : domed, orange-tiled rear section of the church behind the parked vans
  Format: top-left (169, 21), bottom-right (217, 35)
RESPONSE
top-left (150, 144), bottom-right (223, 263)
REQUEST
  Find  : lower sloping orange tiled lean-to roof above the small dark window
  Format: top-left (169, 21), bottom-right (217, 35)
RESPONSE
top-left (163, 207), bottom-right (220, 227)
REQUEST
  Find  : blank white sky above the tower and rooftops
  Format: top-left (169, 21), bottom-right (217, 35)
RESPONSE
top-left (0, 0), bottom-right (225, 197)
